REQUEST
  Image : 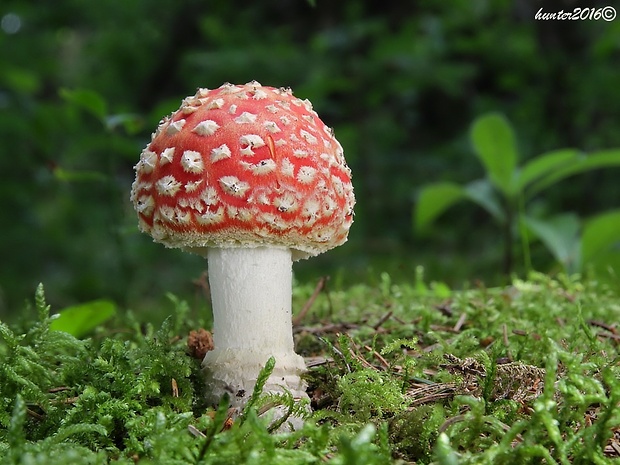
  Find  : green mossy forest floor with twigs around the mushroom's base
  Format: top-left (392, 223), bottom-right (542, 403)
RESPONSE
top-left (0, 274), bottom-right (620, 464)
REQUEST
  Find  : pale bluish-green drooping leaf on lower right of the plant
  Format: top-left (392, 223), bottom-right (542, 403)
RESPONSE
top-left (523, 213), bottom-right (581, 273)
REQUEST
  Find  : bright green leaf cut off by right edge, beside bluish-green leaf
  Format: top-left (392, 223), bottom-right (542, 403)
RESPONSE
top-left (581, 210), bottom-right (620, 263)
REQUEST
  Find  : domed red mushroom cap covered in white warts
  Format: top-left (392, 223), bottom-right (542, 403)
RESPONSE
top-left (131, 82), bottom-right (355, 260)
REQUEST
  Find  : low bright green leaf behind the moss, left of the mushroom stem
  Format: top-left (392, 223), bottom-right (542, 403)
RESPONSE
top-left (50, 300), bottom-right (116, 337)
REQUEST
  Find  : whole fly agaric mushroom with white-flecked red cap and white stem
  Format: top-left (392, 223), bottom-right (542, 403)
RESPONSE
top-left (131, 82), bottom-right (355, 407)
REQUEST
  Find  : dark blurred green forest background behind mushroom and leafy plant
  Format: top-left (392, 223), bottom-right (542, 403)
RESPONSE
top-left (0, 0), bottom-right (620, 316)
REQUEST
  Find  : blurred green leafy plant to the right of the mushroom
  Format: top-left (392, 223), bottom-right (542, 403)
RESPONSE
top-left (414, 113), bottom-right (620, 274)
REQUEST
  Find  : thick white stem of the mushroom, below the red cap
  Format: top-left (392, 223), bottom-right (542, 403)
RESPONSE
top-left (203, 247), bottom-right (307, 407)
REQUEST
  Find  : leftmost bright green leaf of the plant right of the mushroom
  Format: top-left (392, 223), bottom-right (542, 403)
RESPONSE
top-left (414, 182), bottom-right (464, 230)
